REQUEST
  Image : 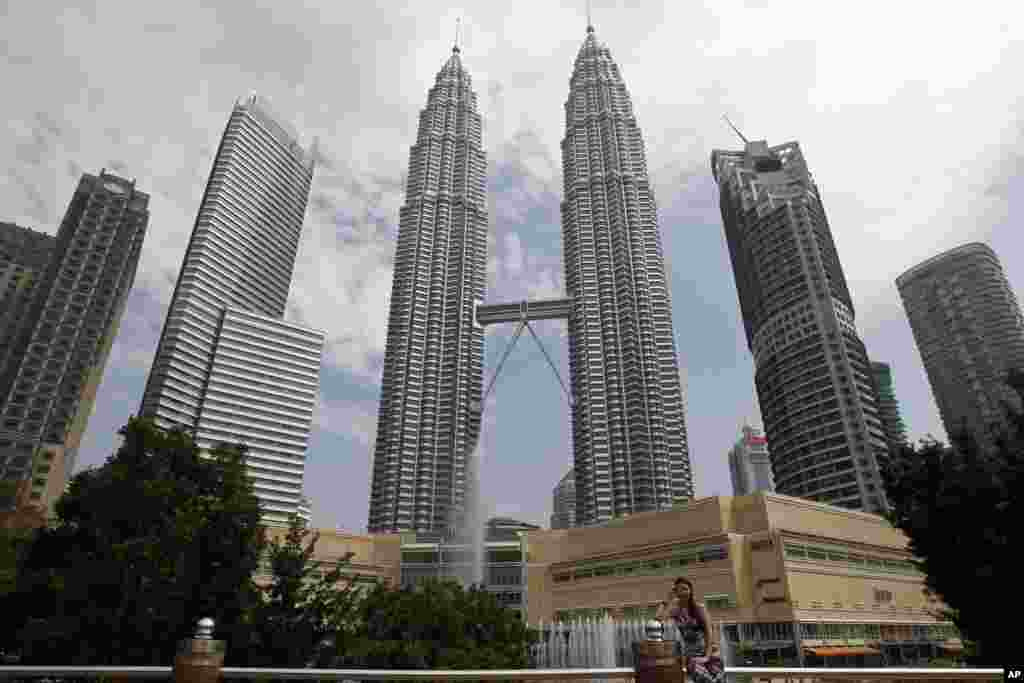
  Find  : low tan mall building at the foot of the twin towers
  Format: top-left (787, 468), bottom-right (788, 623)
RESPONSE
top-left (262, 494), bottom-right (962, 666)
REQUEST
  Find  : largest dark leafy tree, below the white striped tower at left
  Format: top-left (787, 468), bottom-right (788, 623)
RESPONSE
top-left (3, 419), bottom-right (265, 666)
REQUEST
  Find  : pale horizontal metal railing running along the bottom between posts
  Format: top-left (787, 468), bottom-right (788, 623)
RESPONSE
top-left (0, 666), bottom-right (1002, 683)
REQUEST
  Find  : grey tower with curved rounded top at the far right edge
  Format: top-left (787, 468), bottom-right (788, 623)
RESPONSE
top-left (896, 243), bottom-right (1024, 444)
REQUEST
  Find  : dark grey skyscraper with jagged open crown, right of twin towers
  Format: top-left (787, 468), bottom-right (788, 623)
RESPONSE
top-left (711, 140), bottom-right (889, 512)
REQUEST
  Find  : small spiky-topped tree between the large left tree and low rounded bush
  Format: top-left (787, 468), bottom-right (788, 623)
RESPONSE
top-left (227, 515), bottom-right (358, 668)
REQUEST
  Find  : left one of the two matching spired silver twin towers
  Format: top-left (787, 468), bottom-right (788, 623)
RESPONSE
top-left (369, 47), bottom-right (487, 532)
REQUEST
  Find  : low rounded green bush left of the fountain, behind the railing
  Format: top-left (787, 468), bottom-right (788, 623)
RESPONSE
top-left (339, 580), bottom-right (537, 669)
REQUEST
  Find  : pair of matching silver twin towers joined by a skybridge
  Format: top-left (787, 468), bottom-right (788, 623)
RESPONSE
top-left (369, 27), bottom-right (693, 532)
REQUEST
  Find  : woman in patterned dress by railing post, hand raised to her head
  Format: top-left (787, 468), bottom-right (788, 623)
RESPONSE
top-left (654, 577), bottom-right (725, 683)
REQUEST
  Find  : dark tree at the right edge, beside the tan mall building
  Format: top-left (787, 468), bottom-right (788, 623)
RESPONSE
top-left (883, 371), bottom-right (1024, 665)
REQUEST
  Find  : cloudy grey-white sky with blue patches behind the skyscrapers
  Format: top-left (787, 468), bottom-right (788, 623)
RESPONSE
top-left (0, 0), bottom-right (1024, 531)
